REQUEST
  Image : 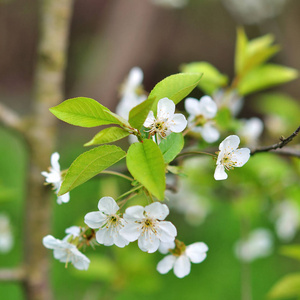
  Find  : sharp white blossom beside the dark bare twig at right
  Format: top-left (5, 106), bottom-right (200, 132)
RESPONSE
top-left (214, 135), bottom-right (250, 180)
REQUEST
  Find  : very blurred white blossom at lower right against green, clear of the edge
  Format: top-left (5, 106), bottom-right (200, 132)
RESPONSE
top-left (234, 228), bottom-right (273, 262)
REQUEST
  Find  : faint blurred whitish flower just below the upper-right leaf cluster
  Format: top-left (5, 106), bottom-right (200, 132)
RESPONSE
top-left (213, 89), bottom-right (244, 116)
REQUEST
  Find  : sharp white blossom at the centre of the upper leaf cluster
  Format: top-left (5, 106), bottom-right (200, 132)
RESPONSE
top-left (144, 98), bottom-right (187, 138)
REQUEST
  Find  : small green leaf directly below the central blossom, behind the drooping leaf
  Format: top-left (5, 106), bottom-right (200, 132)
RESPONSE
top-left (159, 132), bottom-right (184, 163)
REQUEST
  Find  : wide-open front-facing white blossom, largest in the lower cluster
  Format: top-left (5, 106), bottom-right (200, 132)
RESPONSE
top-left (120, 202), bottom-right (177, 253)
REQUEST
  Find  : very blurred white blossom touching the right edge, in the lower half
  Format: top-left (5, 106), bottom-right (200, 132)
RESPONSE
top-left (272, 200), bottom-right (300, 242)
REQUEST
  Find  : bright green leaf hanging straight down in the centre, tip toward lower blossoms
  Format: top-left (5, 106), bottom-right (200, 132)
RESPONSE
top-left (126, 140), bottom-right (166, 200)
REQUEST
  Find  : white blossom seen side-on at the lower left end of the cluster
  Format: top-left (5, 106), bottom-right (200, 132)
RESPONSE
top-left (43, 235), bottom-right (90, 270)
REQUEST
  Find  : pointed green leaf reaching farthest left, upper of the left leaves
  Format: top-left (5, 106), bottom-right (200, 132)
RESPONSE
top-left (50, 97), bottom-right (126, 127)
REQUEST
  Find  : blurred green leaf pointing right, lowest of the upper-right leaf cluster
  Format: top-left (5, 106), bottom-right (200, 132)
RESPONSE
top-left (237, 64), bottom-right (298, 96)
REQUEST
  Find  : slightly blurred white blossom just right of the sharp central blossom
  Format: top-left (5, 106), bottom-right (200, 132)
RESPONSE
top-left (184, 96), bottom-right (220, 143)
